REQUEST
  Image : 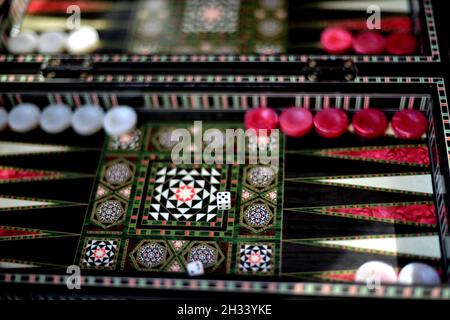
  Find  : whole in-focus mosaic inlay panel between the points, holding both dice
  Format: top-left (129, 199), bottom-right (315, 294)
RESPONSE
top-left (76, 123), bottom-right (284, 275)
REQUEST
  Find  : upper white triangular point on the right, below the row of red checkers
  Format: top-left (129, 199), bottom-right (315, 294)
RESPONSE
top-left (317, 174), bottom-right (433, 194)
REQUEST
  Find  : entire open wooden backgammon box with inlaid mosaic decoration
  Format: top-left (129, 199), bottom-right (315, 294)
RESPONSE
top-left (0, 0), bottom-right (450, 300)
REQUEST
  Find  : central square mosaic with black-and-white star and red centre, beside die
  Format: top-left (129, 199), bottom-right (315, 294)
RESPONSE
top-left (128, 154), bottom-right (243, 237)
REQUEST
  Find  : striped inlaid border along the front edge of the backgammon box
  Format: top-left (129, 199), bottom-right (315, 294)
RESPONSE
top-left (0, 273), bottom-right (450, 300)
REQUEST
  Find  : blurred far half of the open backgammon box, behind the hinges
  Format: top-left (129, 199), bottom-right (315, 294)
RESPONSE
top-left (0, 0), bottom-right (442, 78)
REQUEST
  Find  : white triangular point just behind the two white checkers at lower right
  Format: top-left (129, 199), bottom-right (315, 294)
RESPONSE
top-left (318, 235), bottom-right (441, 259)
